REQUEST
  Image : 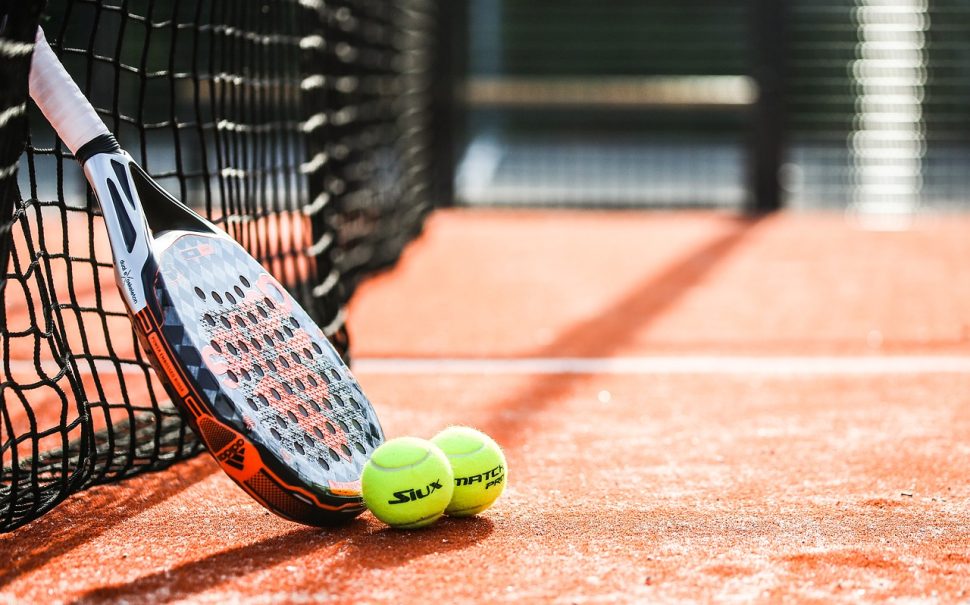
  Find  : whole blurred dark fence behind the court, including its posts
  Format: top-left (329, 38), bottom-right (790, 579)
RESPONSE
top-left (439, 0), bottom-right (970, 214)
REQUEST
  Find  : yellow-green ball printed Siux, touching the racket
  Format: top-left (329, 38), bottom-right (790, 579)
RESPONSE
top-left (360, 437), bottom-right (455, 529)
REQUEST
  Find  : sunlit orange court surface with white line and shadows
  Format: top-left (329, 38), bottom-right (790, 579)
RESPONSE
top-left (0, 211), bottom-right (970, 604)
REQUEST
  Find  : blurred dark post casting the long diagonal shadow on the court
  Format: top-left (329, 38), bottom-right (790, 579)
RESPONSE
top-left (747, 0), bottom-right (788, 214)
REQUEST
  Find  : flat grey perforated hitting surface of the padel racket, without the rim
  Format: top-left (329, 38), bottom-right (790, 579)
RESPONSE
top-left (153, 234), bottom-right (382, 486)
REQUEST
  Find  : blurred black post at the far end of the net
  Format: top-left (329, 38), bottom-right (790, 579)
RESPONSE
top-left (431, 0), bottom-right (468, 207)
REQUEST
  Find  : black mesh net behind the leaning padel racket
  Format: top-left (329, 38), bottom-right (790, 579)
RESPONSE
top-left (0, 0), bottom-right (434, 530)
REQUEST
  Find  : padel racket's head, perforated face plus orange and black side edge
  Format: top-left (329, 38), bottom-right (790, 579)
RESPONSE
top-left (140, 232), bottom-right (383, 525)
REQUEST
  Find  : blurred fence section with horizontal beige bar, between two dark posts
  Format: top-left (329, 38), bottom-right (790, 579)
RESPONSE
top-left (458, 0), bottom-right (753, 208)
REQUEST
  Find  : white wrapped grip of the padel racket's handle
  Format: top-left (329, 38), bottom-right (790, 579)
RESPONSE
top-left (30, 27), bottom-right (108, 154)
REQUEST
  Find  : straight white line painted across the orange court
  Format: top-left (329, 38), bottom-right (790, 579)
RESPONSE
top-left (353, 356), bottom-right (970, 376)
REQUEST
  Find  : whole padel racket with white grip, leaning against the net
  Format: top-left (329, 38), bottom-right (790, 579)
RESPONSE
top-left (30, 28), bottom-right (384, 525)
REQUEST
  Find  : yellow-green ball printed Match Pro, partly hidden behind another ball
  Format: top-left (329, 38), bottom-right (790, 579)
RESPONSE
top-left (431, 426), bottom-right (506, 517)
